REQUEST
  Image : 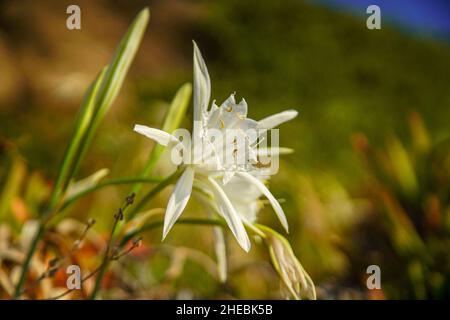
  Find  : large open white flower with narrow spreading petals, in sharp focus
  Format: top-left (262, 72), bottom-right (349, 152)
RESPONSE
top-left (134, 42), bottom-right (297, 251)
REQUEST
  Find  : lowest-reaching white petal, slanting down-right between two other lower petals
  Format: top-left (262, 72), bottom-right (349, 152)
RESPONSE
top-left (208, 177), bottom-right (251, 252)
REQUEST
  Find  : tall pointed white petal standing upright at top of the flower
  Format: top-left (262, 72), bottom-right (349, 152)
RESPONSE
top-left (192, 41), bottom-right (211, 127)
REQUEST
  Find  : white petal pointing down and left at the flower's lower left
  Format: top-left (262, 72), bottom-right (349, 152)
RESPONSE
top-left (163, 167), bottom-right (194, 240)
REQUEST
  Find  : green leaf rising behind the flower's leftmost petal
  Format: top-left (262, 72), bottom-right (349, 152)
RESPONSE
top-left (132, 83), bottom-right (192, 193)
